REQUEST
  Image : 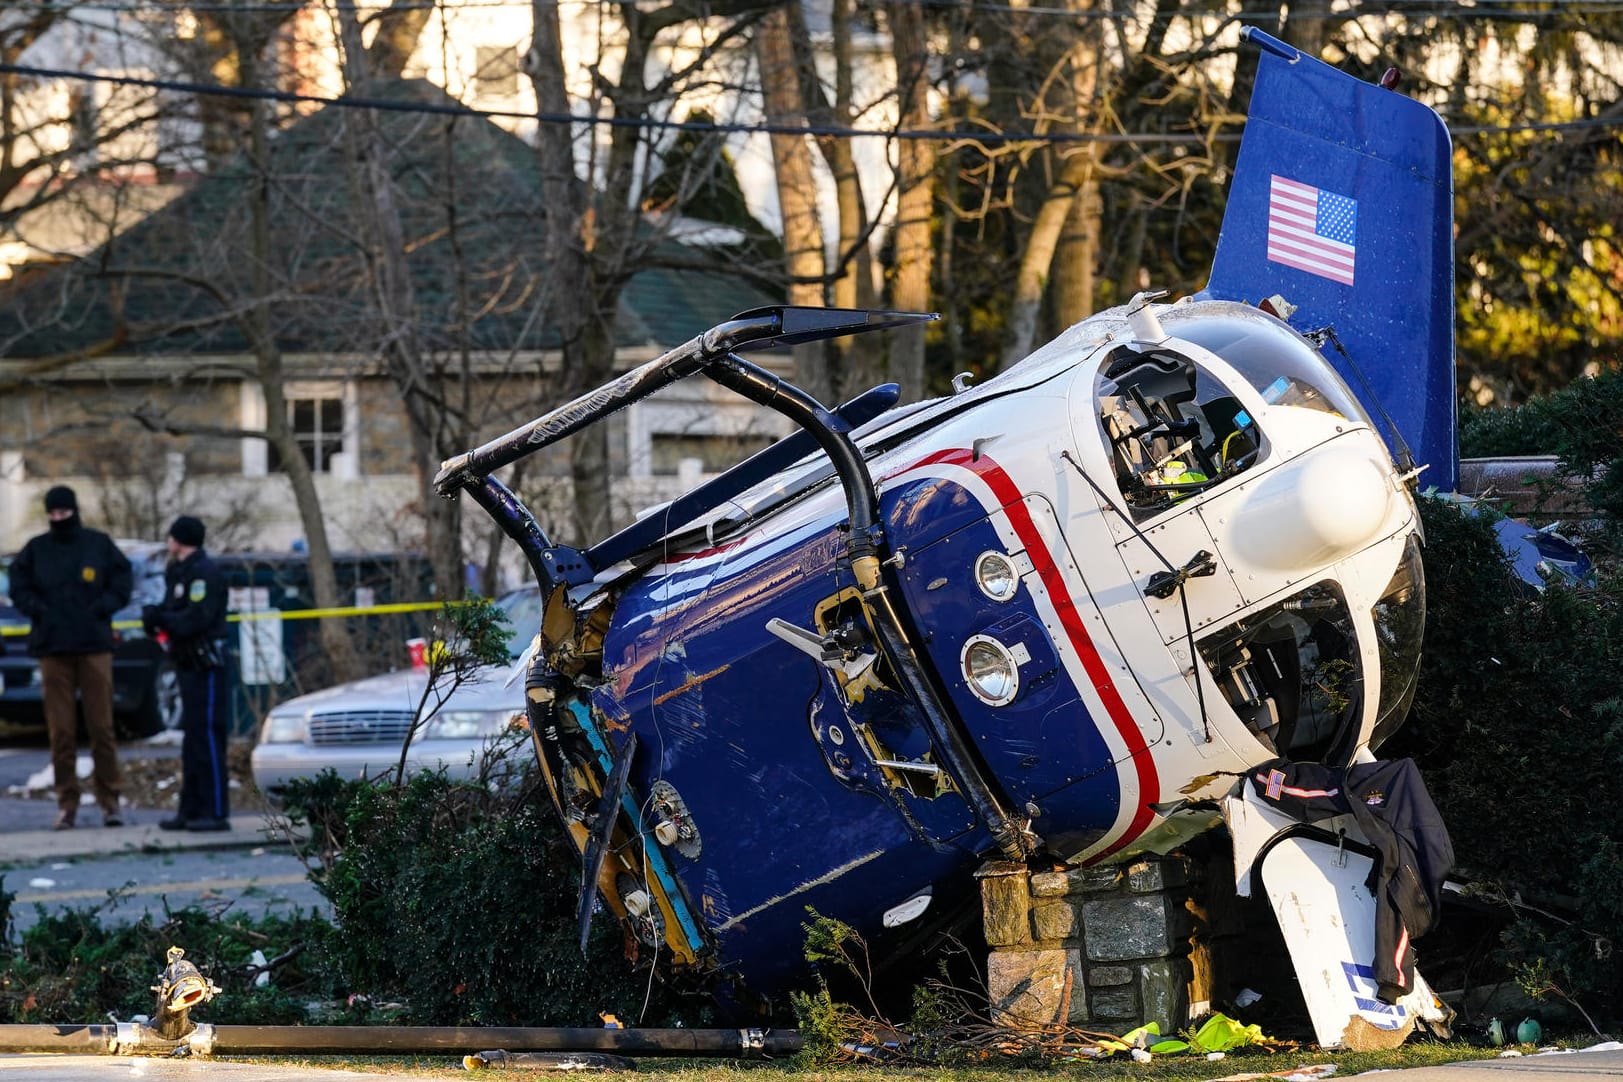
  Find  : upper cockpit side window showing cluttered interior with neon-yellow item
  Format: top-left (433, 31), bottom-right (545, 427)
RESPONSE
top-left (1096, 349), bottom-right (1261, 517)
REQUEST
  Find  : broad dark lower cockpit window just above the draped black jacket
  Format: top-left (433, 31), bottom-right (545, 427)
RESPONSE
top-left (1199, 582), bottom-right (1363, 766)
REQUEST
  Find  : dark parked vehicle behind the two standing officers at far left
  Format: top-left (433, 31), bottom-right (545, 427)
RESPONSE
top-left (0, 540), bottom-right (180, 740)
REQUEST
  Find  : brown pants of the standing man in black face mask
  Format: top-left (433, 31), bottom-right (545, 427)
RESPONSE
top-left (39, 654), bottom-right (122, 814)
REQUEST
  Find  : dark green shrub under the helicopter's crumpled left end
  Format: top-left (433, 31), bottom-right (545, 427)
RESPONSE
top-left (287, 772), bottom-right (709, 1025)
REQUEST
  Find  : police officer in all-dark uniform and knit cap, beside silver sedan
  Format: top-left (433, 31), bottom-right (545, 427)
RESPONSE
top-left (141, 514), bottom-right (230, 831)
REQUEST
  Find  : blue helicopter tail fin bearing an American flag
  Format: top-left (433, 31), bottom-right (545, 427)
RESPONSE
top-left (1204, 28), bottom-right (1457, 492)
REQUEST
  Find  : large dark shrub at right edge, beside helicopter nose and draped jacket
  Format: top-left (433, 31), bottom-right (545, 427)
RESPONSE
top-left (1381, 500), bottom-right (1623, 1017)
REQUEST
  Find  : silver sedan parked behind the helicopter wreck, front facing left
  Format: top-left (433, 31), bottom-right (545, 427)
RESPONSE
top-left (252, 587), bottom-right (540, 805)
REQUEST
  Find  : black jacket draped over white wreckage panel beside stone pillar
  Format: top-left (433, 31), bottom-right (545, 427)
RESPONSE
top-left (1251, 759), bottom-right (1454, 1003)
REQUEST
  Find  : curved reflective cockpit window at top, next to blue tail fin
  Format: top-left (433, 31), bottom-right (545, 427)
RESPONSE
top-left (1167, 313), bottom-right (1370, 423)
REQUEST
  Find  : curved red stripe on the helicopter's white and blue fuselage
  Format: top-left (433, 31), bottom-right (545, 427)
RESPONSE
top-left (898, 448), bottom-right (1160, 860)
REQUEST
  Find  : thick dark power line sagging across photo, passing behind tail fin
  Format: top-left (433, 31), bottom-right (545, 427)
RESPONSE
top-left (0, 63), bottom-right (1623, 146)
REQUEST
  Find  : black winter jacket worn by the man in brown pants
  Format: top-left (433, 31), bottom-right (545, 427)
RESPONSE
top-left (11, 526), bottom-right (131, 657)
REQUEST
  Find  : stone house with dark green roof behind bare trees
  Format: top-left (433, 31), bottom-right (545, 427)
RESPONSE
top-left (0, 81), bottom-right (781, 574)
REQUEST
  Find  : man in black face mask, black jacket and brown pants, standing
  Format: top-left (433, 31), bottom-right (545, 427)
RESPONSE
top-left (11, 485), bottom-right (131, 831)
